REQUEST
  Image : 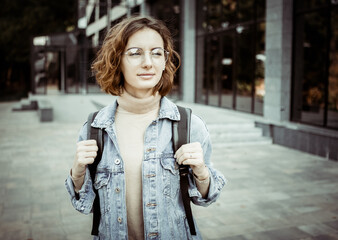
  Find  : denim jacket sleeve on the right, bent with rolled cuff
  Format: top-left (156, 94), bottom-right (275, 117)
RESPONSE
top-left (189, 115), bottom-right (226, 207)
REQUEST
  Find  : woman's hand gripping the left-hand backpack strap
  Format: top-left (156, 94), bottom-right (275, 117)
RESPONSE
top-left (71, 140), bottom-right (98, 180)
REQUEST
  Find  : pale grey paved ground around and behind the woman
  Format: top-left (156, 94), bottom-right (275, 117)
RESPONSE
top-left (0, 95), bottom-right (338, 240)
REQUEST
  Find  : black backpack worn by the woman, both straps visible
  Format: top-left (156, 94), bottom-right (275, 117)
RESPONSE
top-left (87, 106), bottom-right (196, 236)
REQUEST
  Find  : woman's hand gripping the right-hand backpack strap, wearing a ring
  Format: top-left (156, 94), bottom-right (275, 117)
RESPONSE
top-left (174, 142), bottom-right (209, 180)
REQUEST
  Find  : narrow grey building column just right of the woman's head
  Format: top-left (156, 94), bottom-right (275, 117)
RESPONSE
top-left (180, 0), bottom-right (196, 102)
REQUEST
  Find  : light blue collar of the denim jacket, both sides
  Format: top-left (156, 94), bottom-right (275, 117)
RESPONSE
top-left (92, 97), bottom-right (180, 128)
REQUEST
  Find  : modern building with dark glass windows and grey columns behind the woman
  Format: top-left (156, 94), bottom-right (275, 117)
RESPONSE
top-left (32, 0), bottom-right (338, 160)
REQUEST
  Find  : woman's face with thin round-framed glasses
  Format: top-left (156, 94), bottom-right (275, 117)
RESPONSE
top-left (121, 28), bottom-right (166, 98)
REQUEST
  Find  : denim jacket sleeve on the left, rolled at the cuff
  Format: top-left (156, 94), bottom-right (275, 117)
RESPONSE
top-left (65, 124), bottom-right (95, 214)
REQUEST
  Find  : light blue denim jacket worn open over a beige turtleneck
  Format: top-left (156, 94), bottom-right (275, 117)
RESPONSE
top-left (66, 97), bottom-right (226, 240)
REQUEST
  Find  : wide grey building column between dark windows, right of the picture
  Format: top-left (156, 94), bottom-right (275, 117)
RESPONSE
top-left (264, 0), bottom-right (293, 122)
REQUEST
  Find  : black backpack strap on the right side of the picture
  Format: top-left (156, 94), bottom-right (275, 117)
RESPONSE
top-left (172, 106), bottom-right (196, 235)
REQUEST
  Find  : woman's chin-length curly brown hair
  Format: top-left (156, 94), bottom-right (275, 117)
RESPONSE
top-left (92, 16), bottom-right (180, 96)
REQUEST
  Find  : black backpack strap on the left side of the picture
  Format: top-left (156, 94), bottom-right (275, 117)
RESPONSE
top-left (87, 112), bottom-right (104, 236)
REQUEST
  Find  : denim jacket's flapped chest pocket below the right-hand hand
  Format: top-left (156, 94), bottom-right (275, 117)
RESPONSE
top-left (161, 155), bottom-right (180, 198)
